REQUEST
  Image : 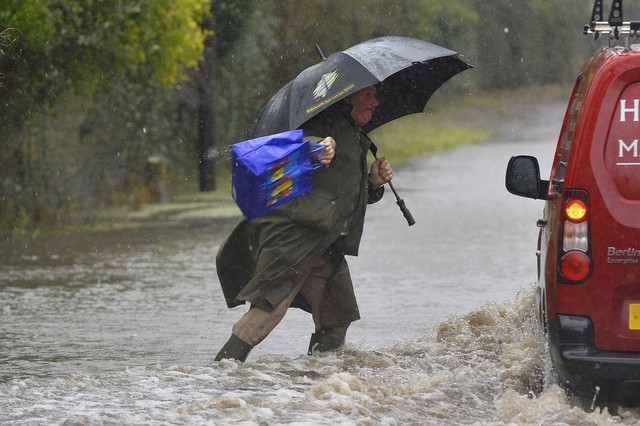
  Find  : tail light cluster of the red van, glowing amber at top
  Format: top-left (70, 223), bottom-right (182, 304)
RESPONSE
top-left (558, 189), bottom-right (593, 284)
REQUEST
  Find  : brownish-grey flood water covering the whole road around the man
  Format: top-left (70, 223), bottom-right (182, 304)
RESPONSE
top-left (0, 98), bottom-right (640, 425)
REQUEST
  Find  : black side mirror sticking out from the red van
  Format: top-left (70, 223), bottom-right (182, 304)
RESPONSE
top-left (505, 155), bottom-right (549, 200)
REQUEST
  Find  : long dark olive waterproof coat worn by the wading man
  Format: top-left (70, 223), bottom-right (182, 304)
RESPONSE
top-left (216, 108), bottom-right (383, 328)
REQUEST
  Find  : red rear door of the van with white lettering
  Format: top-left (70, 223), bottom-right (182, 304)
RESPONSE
top-left (567, 50), bottom-right (640, 351)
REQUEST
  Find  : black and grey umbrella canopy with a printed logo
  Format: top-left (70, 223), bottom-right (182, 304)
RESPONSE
top-left (253, 36), bottom-right (471, 137)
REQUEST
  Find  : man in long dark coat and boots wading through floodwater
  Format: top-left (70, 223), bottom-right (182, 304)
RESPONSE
top-left (216, 86), bottom-right (393, 361)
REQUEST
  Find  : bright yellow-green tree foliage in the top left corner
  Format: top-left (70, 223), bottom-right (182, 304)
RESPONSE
top-left (0, 0), bottom-right (206, 130)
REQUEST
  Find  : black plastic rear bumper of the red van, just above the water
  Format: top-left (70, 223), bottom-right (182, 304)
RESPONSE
top-left (548, 315), bottom-right (640, 405)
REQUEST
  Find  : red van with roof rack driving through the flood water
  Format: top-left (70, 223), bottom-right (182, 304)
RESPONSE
top-left (506, 2), bottom-right (640, 405)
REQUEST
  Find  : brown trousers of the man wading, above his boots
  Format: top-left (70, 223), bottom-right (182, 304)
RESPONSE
top-left (232, 254), bottom-right (349, 349)
